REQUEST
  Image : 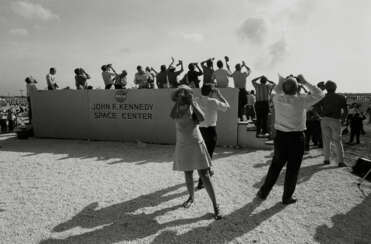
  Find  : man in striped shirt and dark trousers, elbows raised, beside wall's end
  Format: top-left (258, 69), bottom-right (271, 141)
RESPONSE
top-left (251, 75), bottom-right (275, 137)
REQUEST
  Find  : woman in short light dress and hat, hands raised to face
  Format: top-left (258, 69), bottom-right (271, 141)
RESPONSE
top-left (170, 85), bottom-right (221, 220)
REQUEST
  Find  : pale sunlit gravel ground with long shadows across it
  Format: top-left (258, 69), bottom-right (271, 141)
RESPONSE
top-left (0, 125), bottom-right (371, 244)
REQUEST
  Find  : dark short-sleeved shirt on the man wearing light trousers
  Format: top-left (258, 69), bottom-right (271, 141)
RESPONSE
top-left (316, 93), bottom-right (347, 119)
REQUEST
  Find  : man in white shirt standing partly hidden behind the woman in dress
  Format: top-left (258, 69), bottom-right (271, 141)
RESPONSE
top-left (197, 83), bottom-right (229, 189)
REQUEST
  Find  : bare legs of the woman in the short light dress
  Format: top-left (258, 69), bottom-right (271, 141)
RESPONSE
top-left (183, 169), bottom-right (221, 220)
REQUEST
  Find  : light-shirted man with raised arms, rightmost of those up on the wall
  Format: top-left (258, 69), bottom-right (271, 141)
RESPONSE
top-left (232, 61), bottom-right (251, 121)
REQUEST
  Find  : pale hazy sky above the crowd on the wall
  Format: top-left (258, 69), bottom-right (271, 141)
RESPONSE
top-left (0, 0), bottom-right (371, 95)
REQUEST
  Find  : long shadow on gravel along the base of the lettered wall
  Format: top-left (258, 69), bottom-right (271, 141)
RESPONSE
top-left (0, 135), bottom-right (262, 165)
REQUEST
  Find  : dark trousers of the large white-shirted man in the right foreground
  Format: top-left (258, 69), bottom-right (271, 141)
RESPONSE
top-left (259, 130), bottom-right (304, 201)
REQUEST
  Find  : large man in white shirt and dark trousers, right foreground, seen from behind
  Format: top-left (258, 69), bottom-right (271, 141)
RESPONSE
top-left (257, 75), bottom-right (323, 204)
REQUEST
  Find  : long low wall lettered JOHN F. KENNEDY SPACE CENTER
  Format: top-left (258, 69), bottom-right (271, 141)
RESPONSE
top-left (31, 88), bottom-right (238, 145)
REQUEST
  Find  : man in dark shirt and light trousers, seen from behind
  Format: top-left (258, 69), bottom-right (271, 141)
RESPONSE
top-left (316, 80), bottom-right (348, 167)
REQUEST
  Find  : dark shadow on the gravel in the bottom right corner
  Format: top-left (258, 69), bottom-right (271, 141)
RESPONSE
top-left (314, 194), bottom-right (371, 244)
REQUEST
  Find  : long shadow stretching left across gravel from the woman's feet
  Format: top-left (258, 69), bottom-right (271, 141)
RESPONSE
top-left (40, 184), bottom-right (210, 244)
